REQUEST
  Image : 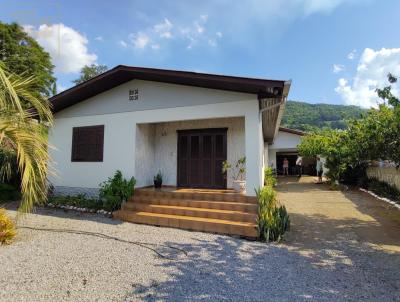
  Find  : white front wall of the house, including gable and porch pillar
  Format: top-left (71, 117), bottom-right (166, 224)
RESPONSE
top-left (49, 81), bottom-right (263, 195)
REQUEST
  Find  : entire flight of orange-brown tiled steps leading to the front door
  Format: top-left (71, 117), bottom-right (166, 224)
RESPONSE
top-left (114, 187), bottom-right (257, 238)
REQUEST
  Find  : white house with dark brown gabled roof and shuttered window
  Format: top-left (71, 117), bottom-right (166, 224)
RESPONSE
top-left (49, 65), bottom-right (290, 195)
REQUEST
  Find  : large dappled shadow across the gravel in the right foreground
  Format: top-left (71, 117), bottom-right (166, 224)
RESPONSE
top-left (127, 229), bottom-right (400, 301)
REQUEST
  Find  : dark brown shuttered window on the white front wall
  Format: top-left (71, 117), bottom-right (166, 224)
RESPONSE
top-left (71, 125), bottom-right (104, 162)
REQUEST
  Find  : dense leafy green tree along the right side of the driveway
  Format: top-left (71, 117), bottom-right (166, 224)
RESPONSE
top-left (299, 74), bottom-right (400, 182)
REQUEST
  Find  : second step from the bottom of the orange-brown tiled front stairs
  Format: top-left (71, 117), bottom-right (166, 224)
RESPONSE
top-left (122, 202), bottom-right (257, 223)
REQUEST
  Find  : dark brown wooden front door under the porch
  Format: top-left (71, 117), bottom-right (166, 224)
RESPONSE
top-left (177, 128), bottom-right (227, 189)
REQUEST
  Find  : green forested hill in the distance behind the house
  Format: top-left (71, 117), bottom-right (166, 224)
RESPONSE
top-left (281, 101), bottom-right (366, 131)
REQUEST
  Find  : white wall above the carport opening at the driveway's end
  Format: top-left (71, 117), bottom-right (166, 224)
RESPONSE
top-left (267, 131), bottom-right (302, 168)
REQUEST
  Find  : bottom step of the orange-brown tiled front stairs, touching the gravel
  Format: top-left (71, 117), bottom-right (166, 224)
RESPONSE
top-left (113, 209), bottom-right (257, 238)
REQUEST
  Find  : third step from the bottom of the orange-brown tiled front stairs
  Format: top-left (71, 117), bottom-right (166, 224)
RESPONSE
top-left (128, 196), bottom-right (258, 214)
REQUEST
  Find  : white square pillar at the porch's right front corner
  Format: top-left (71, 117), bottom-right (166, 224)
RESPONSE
top-left (245, 105), bottom-right (264, 196)
